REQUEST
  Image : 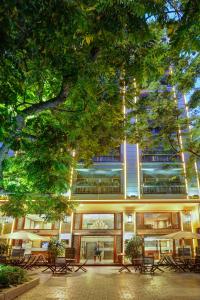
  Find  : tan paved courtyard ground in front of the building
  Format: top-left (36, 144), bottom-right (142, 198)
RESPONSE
top-left (17, 267), bottom-right (200, 300)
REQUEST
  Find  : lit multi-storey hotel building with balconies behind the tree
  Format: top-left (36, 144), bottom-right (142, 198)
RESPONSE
top-left (1, 88), bottom-right (200, 264)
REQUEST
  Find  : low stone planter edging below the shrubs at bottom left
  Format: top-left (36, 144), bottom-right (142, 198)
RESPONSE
top-left (0, 278), bottom-right (40, 300)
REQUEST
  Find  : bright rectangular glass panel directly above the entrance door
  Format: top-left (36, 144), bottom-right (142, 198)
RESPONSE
top-left (82, 214), bottom-right (114, 229)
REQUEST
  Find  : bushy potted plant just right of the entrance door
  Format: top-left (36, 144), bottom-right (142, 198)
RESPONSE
top-left (125, 236), bottom-right (143, 262)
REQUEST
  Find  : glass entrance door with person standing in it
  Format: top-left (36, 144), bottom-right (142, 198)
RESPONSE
top-left (80, 236), bottom-right (114, 264)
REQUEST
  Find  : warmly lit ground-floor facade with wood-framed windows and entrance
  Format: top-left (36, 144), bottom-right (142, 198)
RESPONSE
top-left (0, 199), bottom-right (200, 265)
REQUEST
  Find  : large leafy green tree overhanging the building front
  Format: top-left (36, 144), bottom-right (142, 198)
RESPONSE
top-left (0, 0), bottom-right (198, 219)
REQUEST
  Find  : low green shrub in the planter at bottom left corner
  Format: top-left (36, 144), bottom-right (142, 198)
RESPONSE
top-left (0, 266), bottom-right (27, 288)
